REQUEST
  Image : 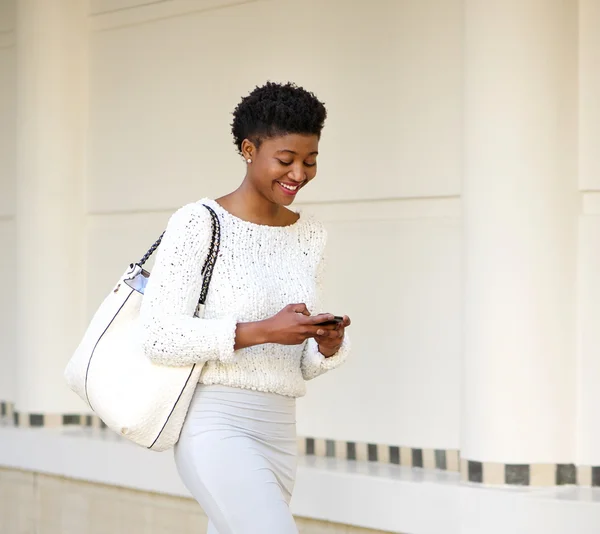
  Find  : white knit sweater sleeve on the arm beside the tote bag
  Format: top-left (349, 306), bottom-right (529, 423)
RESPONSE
top-left (140, 204), bottom-right (237, 366)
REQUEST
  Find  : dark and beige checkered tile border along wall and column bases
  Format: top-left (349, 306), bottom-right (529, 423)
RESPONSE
top-left (0, 402), bottom-right (600, 487)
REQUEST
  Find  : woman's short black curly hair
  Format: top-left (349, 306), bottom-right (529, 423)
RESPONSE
top-left (231, 82), bottom-right (327, 153)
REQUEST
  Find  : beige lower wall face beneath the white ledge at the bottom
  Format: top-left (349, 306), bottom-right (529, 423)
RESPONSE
top-left (0, 468), bottom-right (394, 534)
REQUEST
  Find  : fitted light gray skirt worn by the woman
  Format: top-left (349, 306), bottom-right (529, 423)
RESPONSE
top-left (175, 384), bottom-right (298, 534)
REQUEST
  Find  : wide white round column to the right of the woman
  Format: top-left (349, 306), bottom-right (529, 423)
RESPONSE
top-left (461, 0), bottom-right (579, 464)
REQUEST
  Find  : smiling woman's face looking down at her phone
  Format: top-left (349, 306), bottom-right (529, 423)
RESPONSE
top-left (242, 134), bottom-right (319, 206)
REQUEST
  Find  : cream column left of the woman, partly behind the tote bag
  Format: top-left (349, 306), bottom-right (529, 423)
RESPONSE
top-left (16, 0), bottom-right (87, 413)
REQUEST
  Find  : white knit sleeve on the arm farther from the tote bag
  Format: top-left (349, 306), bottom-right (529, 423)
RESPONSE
top-left (300, 224), bottom-right (350, 380)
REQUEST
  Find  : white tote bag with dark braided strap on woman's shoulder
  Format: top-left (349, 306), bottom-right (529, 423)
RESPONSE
top-left (64, 206), bottom-right (221, 451)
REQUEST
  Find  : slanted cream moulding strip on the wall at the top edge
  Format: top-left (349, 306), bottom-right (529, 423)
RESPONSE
top-left (91, 0), bottom-right (262, 32)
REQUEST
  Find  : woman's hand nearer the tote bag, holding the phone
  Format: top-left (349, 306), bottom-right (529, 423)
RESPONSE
top-left (264, 304), bottom-right (335, 345)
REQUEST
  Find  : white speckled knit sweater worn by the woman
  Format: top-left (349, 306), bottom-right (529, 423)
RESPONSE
top-left (140, 199), bottom-right (350, 397)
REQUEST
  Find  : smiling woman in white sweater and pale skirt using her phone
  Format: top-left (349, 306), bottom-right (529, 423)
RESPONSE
top-left (141, 83), bottom-right (350, 534)
